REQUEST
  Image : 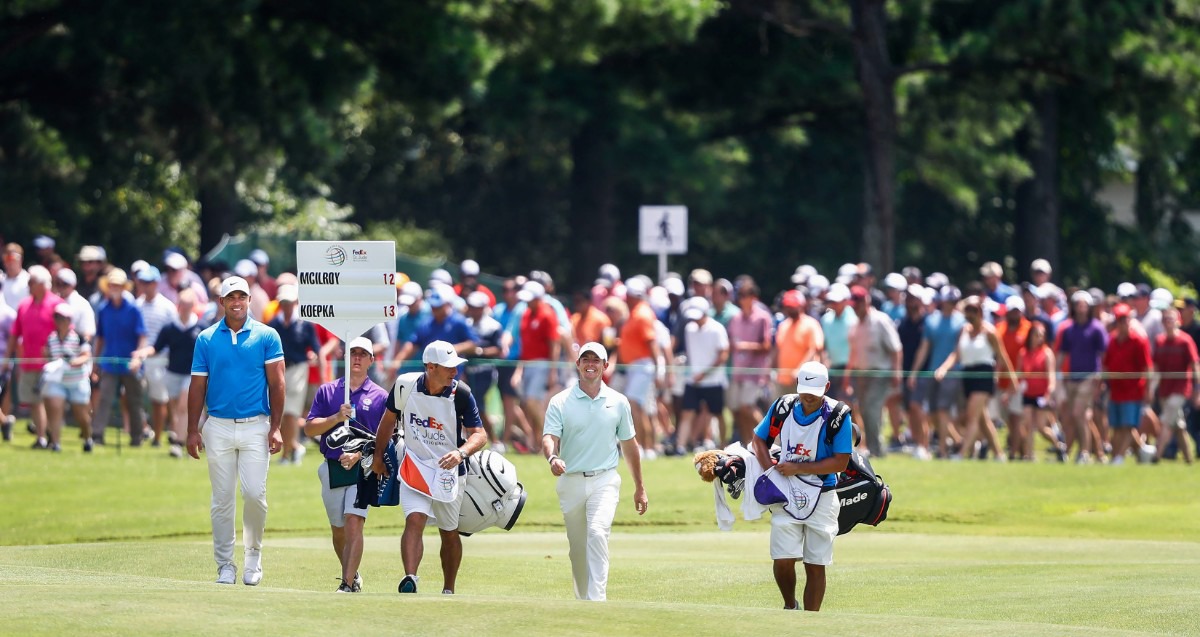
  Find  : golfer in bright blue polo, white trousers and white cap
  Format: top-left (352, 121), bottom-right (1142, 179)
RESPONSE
top-left (187, 276), bottom-right (284, 587)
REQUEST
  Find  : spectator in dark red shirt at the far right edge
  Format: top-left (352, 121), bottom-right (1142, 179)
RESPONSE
top-left (1154, 310), bottom-right (1200, 464)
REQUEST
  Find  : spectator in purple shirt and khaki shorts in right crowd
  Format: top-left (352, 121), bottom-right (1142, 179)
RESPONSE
top-left (1057, 290), bottom-right (1109, 464)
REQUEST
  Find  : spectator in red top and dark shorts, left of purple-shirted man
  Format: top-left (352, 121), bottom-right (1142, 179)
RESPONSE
top-left (1016, 321), bottom-right (1067, 462)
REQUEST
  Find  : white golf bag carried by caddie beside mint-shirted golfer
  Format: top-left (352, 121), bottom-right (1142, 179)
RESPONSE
top-left (458, 449), bottom-right (526, 536)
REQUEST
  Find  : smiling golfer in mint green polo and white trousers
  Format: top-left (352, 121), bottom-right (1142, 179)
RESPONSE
top-left (541, 343), bottom-right (649, 601)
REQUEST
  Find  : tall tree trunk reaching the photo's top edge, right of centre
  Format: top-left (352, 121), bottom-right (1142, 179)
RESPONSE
top-left (851, 0), bottom-right (896, 272)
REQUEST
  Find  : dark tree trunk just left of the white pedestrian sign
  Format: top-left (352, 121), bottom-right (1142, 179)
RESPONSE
top-left (560, 119), bottom-right (614, 292)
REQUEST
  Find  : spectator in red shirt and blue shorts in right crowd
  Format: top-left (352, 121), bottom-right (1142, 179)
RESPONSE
top-left (1102, 304), bottom-right (1152, 464)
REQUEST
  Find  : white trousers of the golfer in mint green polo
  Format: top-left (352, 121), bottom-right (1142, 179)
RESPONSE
top-left (557, 469), bottom-right (620, 601)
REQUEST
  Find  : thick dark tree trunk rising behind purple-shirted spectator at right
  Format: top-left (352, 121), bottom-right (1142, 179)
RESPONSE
top-left (1013, 88), bottom-right (1061, 280)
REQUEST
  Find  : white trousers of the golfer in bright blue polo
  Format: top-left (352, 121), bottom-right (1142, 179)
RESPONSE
top-left (200, 415), bottom-right (271, 567)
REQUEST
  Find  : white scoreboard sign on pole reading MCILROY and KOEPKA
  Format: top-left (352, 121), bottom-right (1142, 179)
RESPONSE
top-left (296, 241), bottom-right (396, 403)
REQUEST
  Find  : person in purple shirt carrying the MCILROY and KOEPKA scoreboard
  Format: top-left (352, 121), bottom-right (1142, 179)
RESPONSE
top-left (304, 336), bottom-right (388, 593)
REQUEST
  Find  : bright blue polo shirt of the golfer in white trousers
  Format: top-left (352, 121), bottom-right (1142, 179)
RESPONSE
top-left (192, 318), bottom-right (283, 417)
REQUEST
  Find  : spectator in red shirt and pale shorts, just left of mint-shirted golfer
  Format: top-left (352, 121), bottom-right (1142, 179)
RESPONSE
top-left (517, 281), bottom-right (562, 440)
